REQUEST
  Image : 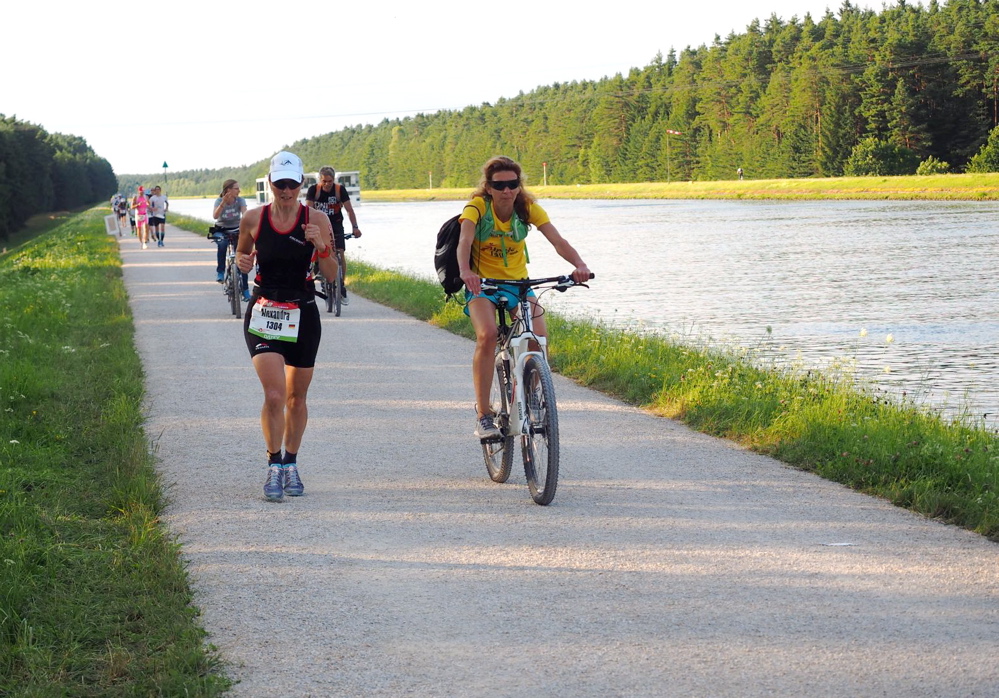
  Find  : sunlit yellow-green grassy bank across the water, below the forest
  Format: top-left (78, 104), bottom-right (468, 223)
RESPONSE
top-left (362, 173), bottom-right (999, 202)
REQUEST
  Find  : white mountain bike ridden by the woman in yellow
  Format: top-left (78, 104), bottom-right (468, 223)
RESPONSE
top-left (482, 274), bottom-right (593, 505)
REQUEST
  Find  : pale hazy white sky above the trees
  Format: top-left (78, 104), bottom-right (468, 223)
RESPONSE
top-left (0, 0), bottom-right (882, 174)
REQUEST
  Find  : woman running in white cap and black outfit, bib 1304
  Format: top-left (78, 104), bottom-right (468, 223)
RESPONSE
top-left (236, 151), bottom-right (337, 501)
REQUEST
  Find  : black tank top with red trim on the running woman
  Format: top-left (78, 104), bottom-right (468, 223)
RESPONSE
top-left (254, 204), bottom-right (316, 301)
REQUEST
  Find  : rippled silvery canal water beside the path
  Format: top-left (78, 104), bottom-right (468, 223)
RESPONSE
top-left (171, 194), bottom-right (999, 427)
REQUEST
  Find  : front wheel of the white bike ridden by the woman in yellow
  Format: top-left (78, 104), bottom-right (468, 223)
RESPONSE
top-left (521, 356), bottom-right (558, 504)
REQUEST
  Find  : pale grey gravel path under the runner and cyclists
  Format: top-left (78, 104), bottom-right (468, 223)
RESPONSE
top-left (121, 226), bottom-right (999, 697)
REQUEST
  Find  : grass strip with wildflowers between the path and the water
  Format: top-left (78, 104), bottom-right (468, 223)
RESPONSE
top-left (340, 261), bottom-right (999, 541)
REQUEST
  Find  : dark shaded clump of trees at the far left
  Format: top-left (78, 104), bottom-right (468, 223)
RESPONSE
top-left (0, 114), bottom-right (118, 240)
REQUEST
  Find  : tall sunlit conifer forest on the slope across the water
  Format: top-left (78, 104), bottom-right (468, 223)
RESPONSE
top-left (129, 0), bottom-right (999, 193)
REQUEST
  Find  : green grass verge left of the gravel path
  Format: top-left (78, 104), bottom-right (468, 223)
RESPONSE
top-left (0, 208), bottom-right (228, 696)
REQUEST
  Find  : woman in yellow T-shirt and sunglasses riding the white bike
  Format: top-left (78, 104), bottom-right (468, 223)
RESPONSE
top-left (458, 156), bottom-right (590, 439)
